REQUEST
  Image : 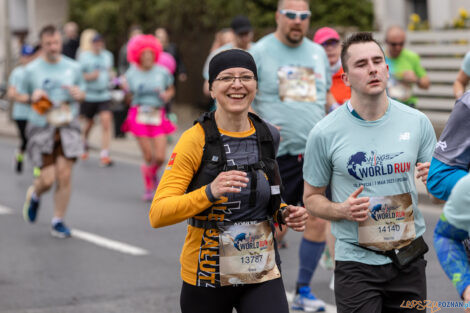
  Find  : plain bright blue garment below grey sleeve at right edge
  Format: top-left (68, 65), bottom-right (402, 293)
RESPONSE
top-left (427, 158), bottom-right (468, 201)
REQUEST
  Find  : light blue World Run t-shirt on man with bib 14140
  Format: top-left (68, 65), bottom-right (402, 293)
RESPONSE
top-left (303, 99), bottom-right (436, 265)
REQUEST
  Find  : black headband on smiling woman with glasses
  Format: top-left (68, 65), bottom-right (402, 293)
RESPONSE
top-left (209, 49), bottom-right (258, 89)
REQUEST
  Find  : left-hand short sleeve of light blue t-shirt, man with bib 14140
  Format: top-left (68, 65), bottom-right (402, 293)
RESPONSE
top-left (303, 126), bottom-right (333, 187)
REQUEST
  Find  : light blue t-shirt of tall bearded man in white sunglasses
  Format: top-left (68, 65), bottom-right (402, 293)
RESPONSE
top-left (250, 34), bottom-right (331, 156)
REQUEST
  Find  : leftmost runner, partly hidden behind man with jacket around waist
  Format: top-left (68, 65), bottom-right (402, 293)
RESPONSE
top-left (7, 45), bottom-right (38, 173)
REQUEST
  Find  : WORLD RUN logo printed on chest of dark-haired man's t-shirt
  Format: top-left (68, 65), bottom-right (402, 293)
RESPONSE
top-left (347, 151), bottom-right (411, 180)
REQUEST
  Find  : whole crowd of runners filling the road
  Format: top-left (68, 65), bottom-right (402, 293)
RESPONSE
top-left (8, 0), bottom-right (470, 313)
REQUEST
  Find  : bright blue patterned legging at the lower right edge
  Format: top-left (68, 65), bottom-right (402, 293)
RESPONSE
top-left (434, 215), bottom-right (470, 296)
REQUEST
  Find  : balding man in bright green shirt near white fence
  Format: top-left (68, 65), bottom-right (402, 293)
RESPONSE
top-left (385, 26), bottom-right (430, 108)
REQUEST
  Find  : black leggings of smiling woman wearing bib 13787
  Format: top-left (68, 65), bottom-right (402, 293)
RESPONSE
top-left (180, 278), bottom-right (289, 313)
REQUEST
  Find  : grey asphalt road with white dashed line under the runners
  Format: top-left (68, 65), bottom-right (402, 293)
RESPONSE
top-left (0, 138), bottom-right (462, 313)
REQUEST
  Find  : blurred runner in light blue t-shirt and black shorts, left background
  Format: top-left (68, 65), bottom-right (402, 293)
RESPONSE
top-left (78, 34), bottom-right (114, 167)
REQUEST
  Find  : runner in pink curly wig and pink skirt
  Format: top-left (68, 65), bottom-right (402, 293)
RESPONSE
top-left (122, 35), bottom-right (176, 201)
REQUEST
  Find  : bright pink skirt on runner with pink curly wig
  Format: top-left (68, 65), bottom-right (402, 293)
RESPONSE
top-left (121, 106), bottom-right (176, 137)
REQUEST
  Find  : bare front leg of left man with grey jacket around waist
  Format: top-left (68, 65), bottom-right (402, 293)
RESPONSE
top-left (54, 156), bottom-right (74, 219)
